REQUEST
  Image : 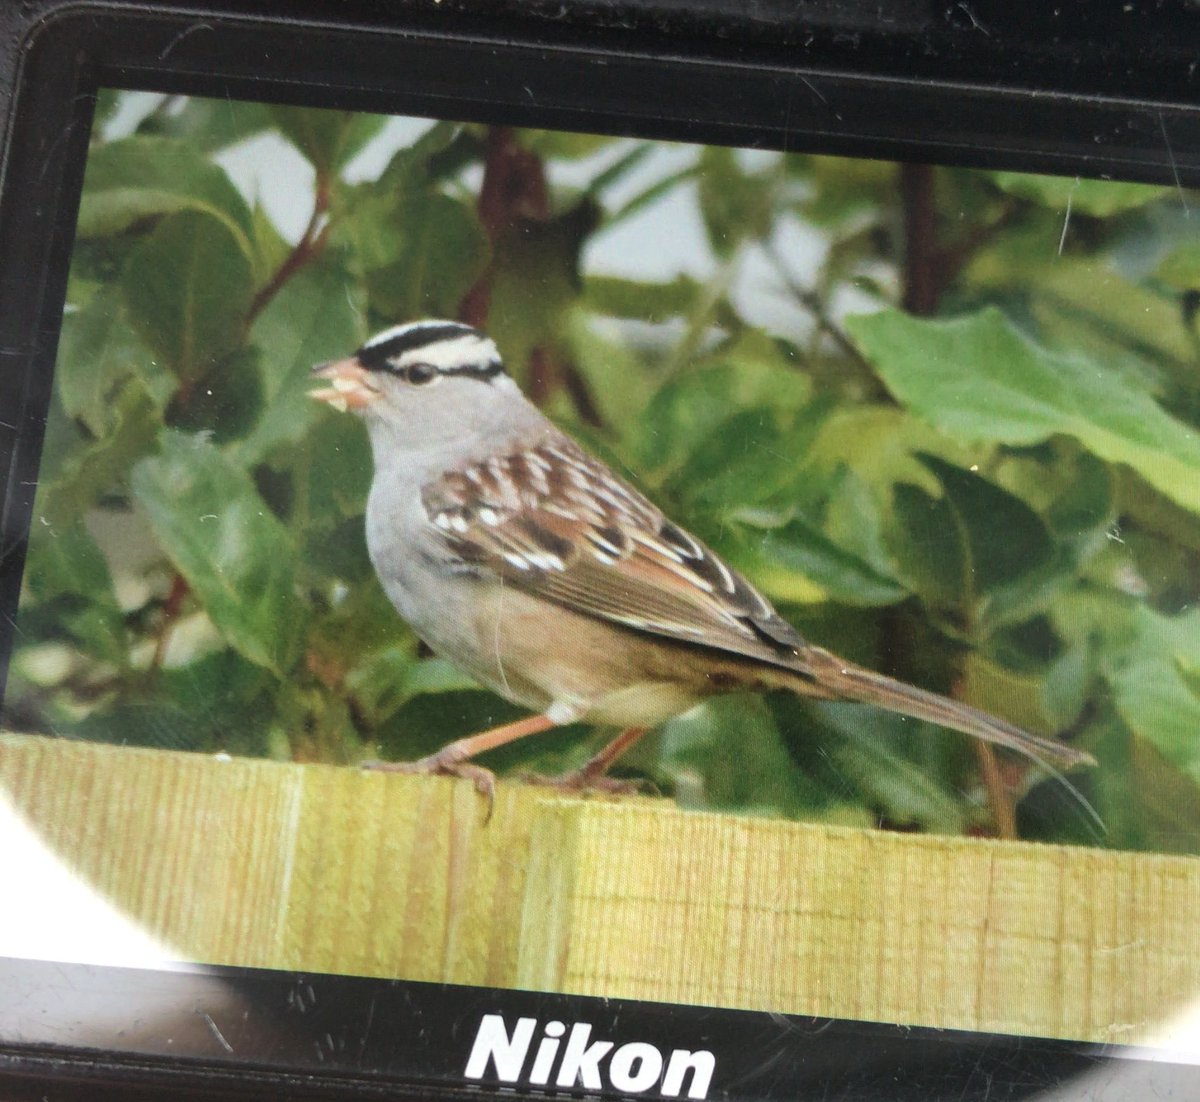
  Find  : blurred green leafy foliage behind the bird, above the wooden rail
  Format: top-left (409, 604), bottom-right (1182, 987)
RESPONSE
top-left (5, 95), bottom-right (1200, 852)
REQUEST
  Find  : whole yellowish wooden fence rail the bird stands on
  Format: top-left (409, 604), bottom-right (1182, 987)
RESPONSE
top-left (0, 735), bottom-right (1200, 1041)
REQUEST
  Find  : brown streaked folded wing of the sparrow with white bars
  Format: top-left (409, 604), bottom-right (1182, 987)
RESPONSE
top-left (422, 437), bottom-right (806, 669)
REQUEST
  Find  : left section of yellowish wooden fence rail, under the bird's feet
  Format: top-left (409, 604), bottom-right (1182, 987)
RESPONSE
top-left (0, 735), bottom-right (536, 986)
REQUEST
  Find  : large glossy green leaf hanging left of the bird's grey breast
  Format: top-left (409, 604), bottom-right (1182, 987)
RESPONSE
top-left (131, 432), bottom-right (302, 675)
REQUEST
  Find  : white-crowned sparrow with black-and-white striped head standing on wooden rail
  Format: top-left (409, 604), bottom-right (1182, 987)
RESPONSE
top-left (313, 321), bottom-right (1092, 792)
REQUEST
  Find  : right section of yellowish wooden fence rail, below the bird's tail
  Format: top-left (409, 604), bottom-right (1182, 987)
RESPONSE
top-left (518, 803), bottom-right (1200, 1042)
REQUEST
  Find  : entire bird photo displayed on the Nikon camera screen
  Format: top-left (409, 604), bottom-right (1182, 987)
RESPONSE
top-left (0, 92), bottom-right (1200, 1043)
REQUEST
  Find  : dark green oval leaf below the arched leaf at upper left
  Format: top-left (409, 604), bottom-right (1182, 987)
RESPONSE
top-left (121, 211), bottom-right (254, 382)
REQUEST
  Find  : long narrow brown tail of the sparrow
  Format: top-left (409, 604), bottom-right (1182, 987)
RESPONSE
top-left (797, 647), bottom-right (1096, 768)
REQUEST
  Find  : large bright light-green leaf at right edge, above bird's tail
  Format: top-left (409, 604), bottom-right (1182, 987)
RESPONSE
top-left (846, 309), bottom-right (1200, 511)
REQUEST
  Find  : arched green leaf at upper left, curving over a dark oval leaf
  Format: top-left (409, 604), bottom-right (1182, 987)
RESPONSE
top-left (76, 137), bottom-right (253, 258)
